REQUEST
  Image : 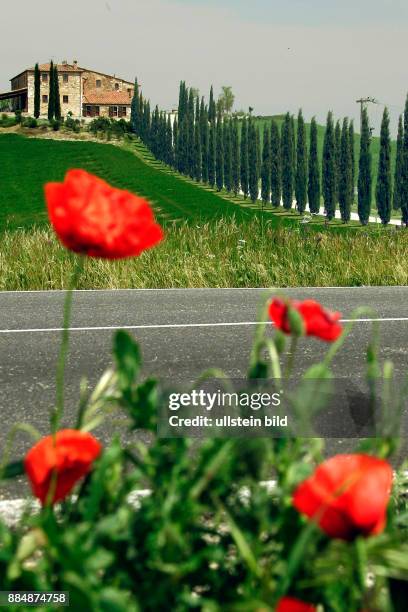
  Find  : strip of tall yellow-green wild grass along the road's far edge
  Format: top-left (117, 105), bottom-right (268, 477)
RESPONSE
top-left (0, 218), bottom-right (408, 290)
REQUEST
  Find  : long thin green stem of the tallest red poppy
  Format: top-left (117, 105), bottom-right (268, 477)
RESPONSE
top-left (51, 257), bottom-right (84, 434)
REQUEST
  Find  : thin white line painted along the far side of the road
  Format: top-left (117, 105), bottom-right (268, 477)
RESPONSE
top-left (0, 317), bottom-right (408, 334)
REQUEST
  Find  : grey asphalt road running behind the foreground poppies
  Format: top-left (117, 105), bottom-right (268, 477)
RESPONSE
top-left (0, 287), bottom-right (408, 499)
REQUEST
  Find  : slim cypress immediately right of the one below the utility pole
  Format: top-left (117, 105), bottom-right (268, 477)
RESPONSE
top-left (375, 108), bottom-right (392, 225)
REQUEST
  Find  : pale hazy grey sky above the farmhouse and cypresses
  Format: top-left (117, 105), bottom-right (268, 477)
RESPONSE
top-left (0, 0), bottom-right (408, 132)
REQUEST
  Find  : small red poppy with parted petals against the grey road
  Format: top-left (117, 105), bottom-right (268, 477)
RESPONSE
top-left (269, 298), bottom-right (343, 342)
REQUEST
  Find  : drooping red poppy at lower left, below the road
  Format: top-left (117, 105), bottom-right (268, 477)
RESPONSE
top-left (24, 429), bottom-right (102, 504)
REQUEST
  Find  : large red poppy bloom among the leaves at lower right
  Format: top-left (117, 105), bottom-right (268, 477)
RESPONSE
top-left (293, 455), bottom-right (392, 540)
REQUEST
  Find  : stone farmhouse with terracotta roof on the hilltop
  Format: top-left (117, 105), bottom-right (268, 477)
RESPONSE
top-left (0, 61), bottom-right (134, 119)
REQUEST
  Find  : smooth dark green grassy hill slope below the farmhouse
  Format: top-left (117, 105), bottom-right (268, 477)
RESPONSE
top-left (0, 134), bottom-right (256, 229)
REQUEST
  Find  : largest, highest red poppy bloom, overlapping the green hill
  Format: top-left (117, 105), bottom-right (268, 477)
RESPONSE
top-left (45, 170), bottom-right (163, 259)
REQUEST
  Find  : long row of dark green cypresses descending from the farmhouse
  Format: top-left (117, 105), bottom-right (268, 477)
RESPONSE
top-left (131, 80), bottom-right (408, 225)
